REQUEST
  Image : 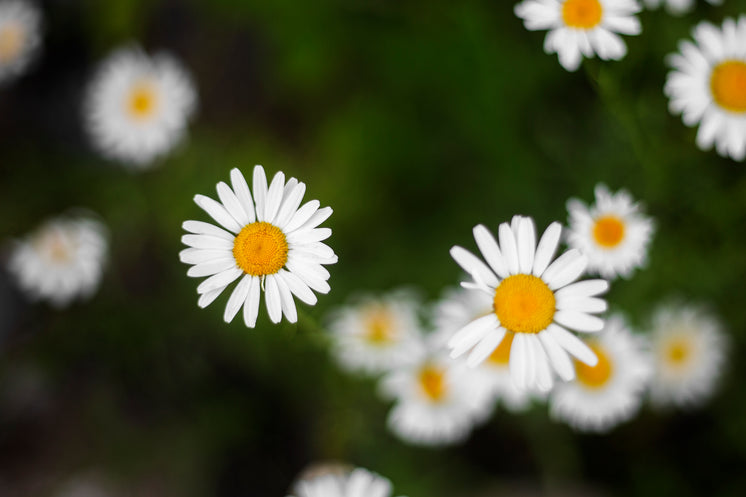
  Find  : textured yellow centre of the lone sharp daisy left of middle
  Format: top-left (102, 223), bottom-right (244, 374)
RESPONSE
top-left (233, 221), bottom-right (288, 276)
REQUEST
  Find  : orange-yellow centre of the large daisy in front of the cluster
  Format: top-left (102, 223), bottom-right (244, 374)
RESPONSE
top-left (494, 274), bottom-right (555, 333)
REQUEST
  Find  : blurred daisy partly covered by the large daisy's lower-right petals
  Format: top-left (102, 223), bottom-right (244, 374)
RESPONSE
top-left (550, 315), bottom-right (651, 432)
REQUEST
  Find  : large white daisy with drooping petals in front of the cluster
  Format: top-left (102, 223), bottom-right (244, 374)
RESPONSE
top-left (448, 216), bottom-right (608, 391)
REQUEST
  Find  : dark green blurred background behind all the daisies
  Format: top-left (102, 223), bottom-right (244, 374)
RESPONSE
top-left (0, 0), bottom-right (746, 497)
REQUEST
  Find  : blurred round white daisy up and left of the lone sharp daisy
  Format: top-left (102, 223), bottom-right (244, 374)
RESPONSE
top-left (85, 47), bottom-right (197, 169)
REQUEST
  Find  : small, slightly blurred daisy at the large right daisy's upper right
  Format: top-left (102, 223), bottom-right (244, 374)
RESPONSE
top-left (567, 184), bottom-right (654, 279)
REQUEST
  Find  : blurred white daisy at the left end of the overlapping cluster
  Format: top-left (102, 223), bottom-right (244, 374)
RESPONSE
top-left (328, 290), bottom-right (423, 373)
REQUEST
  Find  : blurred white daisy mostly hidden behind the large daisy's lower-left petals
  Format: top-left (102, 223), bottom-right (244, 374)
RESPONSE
top-left (433, 288), bottom-right (536, 412)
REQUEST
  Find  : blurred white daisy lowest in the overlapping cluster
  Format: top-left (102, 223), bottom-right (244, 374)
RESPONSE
top-left (381, 353), bottom-right (493, 446)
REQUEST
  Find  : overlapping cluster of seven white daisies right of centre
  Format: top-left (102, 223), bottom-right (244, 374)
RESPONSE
top-left (328, 185), bottom-right (725, 445)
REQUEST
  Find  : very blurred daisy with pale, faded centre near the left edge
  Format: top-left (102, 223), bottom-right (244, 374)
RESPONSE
top-left (8, 215), bottom-right (108, 307)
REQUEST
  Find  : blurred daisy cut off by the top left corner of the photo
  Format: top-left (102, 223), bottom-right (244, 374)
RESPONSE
top-left (0, 0), bottom-right (41, 83)
